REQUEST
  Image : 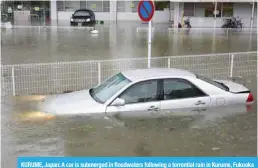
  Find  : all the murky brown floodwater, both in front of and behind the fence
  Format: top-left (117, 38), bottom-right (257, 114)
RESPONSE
top-left (1, 24), bottom-right (257, 167)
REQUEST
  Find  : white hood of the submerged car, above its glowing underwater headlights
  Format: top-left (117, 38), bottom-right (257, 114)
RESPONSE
top-left (40, 90), bottom-right (105, 115)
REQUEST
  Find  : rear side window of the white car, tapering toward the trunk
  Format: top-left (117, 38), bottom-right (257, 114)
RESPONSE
top-left (164, 79), bottom-right (206, 100)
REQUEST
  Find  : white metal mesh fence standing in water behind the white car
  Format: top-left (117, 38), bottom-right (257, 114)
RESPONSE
top-left (1, 52), bottom-right (257, 96)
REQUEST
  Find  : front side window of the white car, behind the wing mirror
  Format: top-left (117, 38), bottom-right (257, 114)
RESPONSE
top-left (119, 80), bottom-right (158, 104)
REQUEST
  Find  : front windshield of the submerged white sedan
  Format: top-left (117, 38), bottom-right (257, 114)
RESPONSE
top-left (90, 73), bottom-right (131, 103)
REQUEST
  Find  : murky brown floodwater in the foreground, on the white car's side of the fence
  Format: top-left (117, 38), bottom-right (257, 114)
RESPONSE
top-left (2, 77), bottom-right (257, 167)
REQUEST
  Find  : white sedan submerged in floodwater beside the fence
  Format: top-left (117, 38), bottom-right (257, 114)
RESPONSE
top-left (42, 68), bottom-right (254, 116)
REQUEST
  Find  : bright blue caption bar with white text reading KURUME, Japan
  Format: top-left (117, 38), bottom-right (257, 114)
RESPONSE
top-left (17, 157), bottom-right (258, 168)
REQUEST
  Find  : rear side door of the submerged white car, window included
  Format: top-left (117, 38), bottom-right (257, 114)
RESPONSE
top-left (160, 78), bottom-right (211, 116)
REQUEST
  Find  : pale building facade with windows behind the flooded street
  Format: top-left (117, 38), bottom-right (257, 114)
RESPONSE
top-left (1, 0), bottom-right (257, 28)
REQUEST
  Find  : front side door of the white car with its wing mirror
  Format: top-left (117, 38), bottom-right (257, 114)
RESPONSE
top-left (106, 80), bottom-right (161, 116)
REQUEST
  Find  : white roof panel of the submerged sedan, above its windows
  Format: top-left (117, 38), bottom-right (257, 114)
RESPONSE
top-left (122, 68), bottom-right (196, 81)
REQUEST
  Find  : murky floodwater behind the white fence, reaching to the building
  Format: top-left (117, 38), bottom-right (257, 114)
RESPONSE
top-left (1, 23), bottom-right (257, 64)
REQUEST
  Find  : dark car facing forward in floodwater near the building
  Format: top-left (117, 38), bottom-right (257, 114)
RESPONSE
top-left (70, 9), bottom-right (96, 26)
